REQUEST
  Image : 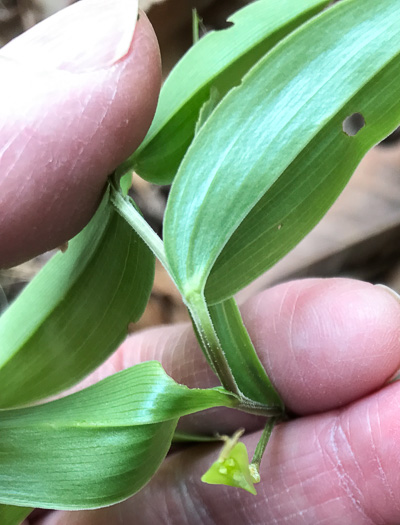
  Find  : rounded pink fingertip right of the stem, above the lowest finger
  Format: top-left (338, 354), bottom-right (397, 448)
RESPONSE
top-left (244, 279), bottom-right (400, 414)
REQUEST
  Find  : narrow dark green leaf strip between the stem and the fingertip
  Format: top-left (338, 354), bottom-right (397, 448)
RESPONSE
top-left (209, 299), bottom-right (283, 409)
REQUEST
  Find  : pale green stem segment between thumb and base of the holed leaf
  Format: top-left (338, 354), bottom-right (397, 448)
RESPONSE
top-left (111, 185), bottom-right (173, 278)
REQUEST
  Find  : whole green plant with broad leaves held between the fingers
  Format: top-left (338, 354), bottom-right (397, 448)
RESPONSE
top-left (0, 0), bottom-right (400, 523)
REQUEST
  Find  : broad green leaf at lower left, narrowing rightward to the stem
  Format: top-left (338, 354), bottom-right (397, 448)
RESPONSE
top-left (0, 361), bottom-right (238, 509)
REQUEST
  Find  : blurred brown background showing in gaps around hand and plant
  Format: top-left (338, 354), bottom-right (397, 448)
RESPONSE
top-left (0, 0), bottom-right (400, 330)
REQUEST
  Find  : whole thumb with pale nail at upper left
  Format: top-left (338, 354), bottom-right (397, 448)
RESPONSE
top-left (0, 0), bottom-right (160, 267)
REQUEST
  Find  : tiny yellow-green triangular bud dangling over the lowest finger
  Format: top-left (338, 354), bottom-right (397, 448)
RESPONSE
top-left (201, 429), bottom-right (260, 495)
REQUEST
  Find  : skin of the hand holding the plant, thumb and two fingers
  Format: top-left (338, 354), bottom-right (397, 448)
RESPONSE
top-left (0, 0), bottom-right (400, 525)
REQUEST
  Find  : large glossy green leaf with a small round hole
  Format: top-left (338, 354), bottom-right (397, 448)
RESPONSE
top-left (164, 0), bottom-right (400, 303)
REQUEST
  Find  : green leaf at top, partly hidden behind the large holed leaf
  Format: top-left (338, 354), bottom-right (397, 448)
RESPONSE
top-left (125, 0), bottom-right (329, 184)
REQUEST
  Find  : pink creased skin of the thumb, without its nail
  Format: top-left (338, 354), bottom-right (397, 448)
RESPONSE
top-left (0, 14), bottom-right (161, 267)
